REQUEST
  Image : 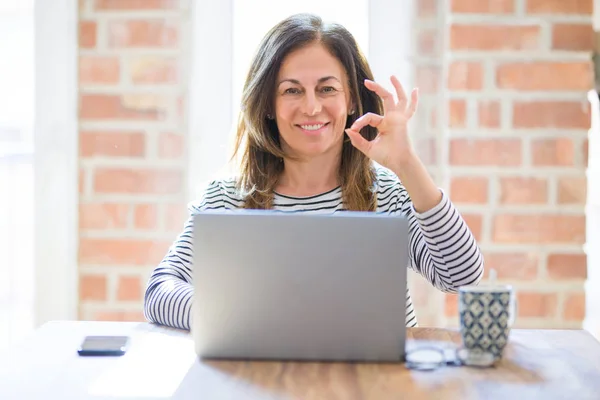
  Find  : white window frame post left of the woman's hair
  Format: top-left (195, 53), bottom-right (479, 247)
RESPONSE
top-left (187, 0), bottom-right (233, 197)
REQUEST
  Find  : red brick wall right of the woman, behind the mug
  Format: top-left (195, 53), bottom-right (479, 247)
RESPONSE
top-left (416, 0), bottom-right (593, 327)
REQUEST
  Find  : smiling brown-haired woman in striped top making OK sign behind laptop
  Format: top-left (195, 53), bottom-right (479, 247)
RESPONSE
top-left (145, 14), bottom-right (483, 329)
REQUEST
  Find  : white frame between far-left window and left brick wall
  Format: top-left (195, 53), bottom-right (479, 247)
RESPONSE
top-left (34, 0), bottom-right (79, 326)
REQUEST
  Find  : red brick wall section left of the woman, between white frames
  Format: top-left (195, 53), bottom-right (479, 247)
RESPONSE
top-left (79, 0), bottom-right (189, 320)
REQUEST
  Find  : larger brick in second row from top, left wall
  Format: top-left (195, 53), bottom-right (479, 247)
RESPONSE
top-left (108, 18), bottom-right (179, 48)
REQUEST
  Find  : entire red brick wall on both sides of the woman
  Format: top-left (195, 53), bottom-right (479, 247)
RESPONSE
top-left (74, 0), bottom-right (593, 327)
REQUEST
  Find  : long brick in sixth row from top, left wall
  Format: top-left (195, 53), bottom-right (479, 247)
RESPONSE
top-left (93, 168), bottom-right (183, 194)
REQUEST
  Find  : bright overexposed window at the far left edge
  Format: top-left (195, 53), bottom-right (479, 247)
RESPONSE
top-left (0, 0), bottom-right (34, 349)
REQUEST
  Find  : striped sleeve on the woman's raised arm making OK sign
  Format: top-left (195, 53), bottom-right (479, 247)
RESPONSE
top-left (400, 191), bottom-right (484, 293)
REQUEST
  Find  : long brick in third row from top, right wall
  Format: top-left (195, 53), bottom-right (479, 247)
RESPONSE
top-left (496, 61), bottom-right (594, 91)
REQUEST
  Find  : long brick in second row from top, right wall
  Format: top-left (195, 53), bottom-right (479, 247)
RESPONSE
top-left (450, 24), bottom-right (540, 51)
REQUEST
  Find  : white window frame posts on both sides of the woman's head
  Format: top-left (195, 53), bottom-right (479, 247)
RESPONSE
top-left (188, 0), bottom-right (414, 200)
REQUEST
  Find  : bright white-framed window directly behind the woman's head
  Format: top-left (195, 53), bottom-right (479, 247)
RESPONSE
top-left (188, 0), bottom-right (413, 200)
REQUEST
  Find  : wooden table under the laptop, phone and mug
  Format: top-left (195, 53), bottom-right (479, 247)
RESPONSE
top-left (0, 322), bottom-right (600, 400)
